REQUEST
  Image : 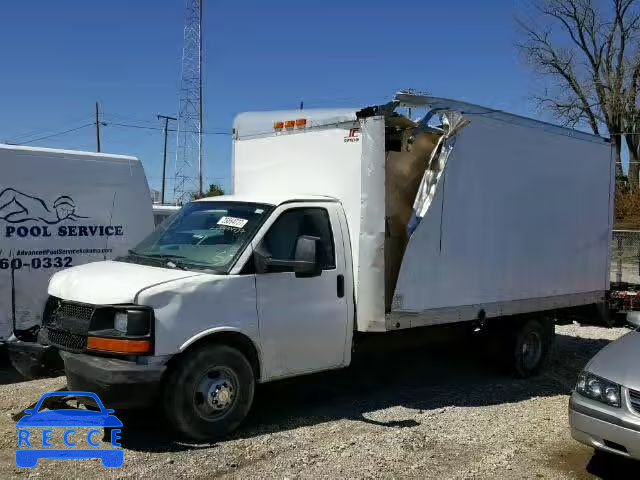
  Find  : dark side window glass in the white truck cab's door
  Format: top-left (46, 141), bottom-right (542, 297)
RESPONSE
top-left (263, 208), bottom-right (336, 272)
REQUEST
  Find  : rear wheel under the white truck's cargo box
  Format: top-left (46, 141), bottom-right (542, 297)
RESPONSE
top-left (506, 319), bottom-right (555, 378)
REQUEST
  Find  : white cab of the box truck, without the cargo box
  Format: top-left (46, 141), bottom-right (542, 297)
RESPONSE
top-left (45, 195), bottom-right (354, 438)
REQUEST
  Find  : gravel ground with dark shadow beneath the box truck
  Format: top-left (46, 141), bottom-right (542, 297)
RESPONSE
top-left (0, 324), bottom-right (640, 479)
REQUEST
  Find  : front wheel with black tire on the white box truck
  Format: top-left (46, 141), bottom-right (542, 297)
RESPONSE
top-left (163, 344), bottom-right (255, 441)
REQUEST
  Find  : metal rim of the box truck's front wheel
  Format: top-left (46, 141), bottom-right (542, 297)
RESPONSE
top-left (193, 367), bottom-right (239, 421)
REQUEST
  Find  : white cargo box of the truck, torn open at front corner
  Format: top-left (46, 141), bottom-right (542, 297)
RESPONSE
top-left (233, 94), bottom-right (614, 332)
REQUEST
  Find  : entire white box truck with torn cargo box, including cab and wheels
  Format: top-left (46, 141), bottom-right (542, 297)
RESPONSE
top-left (40, 93), bottom-right (614, 439)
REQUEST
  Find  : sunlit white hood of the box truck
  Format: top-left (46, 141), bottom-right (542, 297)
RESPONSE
top-left (49, 261), bottom-right (202, 305)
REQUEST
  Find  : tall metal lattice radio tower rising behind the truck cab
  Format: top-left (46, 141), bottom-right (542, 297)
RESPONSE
top-left (173, 0), bottom-right (203, 204)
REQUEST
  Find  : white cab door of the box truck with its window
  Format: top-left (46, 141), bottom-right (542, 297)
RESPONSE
top-left (256, 203), bottom-right (351, 379)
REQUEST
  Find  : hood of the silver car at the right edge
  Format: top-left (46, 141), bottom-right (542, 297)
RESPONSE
top-left (586, 331), bottom-right (640, 390)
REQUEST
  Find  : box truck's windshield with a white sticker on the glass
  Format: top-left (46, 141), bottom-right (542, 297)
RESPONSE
top-left (118, 201), bottom-right (272, 273)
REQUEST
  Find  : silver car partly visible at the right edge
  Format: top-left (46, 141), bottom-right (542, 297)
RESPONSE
top-left (569, 312), bottom-right (640, 460)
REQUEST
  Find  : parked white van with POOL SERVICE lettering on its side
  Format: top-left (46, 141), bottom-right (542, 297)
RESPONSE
top-left (0, 145), bottom-right (154, 341)
